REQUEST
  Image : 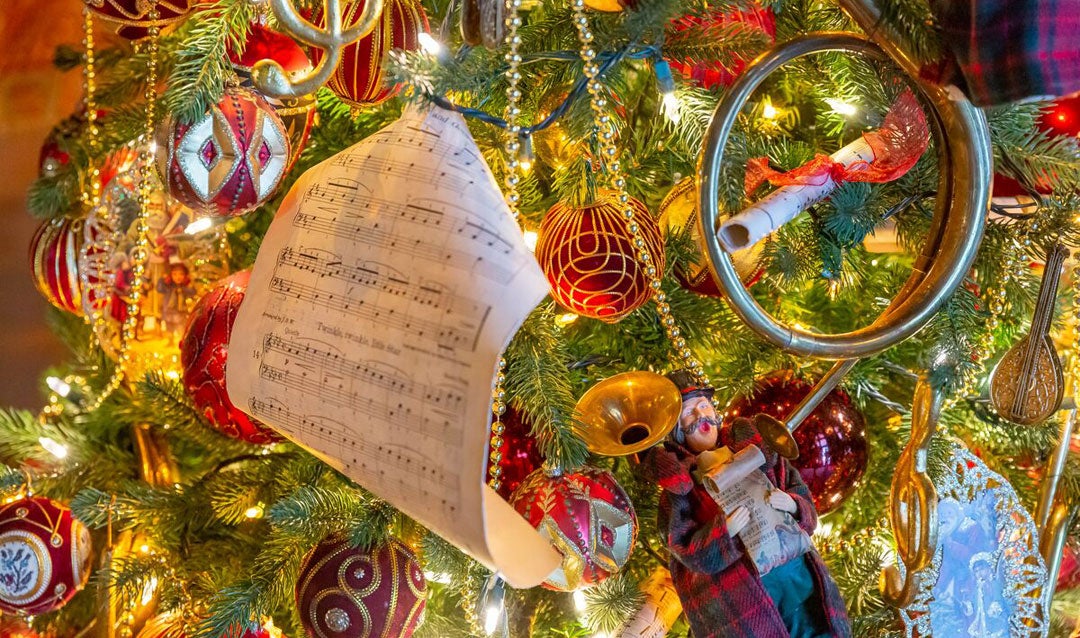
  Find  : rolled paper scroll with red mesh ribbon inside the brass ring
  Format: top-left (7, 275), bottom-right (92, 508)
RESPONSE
top-left (716, 90), bottom-right (930, 253)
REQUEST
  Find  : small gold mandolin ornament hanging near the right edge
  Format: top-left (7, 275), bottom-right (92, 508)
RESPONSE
top-left (990, 244), bottom-right (1069, 425)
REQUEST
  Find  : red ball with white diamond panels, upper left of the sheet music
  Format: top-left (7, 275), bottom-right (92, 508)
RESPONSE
top-left (158, 87), bottom-right (289, 217)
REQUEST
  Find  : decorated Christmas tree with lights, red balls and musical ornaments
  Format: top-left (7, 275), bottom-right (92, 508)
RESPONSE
top-left (6, 0), bottom-right (1080, 638)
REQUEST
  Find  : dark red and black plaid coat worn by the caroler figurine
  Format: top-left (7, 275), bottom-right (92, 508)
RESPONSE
top-left (650, 419), bottom-right (851, 638)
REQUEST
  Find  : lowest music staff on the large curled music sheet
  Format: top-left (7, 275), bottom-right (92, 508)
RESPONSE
top-left (248, 398), bottom-right (460, 494)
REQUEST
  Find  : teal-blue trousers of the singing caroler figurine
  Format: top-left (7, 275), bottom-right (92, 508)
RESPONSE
top-left (761, 555), bottom-right (829, 638)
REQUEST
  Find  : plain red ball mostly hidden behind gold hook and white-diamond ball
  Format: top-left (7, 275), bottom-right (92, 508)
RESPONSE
top-left (226, 24), bottom-right (315, 172)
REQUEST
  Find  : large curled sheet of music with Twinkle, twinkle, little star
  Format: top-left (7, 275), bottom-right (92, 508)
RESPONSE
top-left (227, 109), bottom-right (559, 587)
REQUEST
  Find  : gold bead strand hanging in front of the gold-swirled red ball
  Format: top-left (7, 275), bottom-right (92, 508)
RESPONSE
top-left (571, 0), bottom-right (710, 385)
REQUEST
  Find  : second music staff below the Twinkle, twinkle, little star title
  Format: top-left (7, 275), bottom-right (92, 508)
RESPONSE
top-left (259, 361), bottom-right (458, 446)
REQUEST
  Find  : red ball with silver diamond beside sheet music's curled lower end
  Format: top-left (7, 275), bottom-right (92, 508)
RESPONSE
top-left (511, 466), bottom-right (637, 592)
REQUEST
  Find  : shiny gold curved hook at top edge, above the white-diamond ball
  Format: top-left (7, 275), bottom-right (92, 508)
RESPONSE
top-left (252, 0), bottom-right (382, 98)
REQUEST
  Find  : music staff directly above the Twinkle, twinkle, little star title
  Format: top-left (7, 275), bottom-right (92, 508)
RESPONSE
top-left (270, 271), bottom-right (487, 352)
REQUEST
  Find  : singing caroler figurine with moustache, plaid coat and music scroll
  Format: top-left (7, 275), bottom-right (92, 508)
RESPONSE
top-left (650, 370), bottom-right (851, 638)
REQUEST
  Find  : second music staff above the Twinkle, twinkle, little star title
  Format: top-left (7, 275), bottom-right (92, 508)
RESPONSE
top-left (278, 246), bottom-right (483, 314)
